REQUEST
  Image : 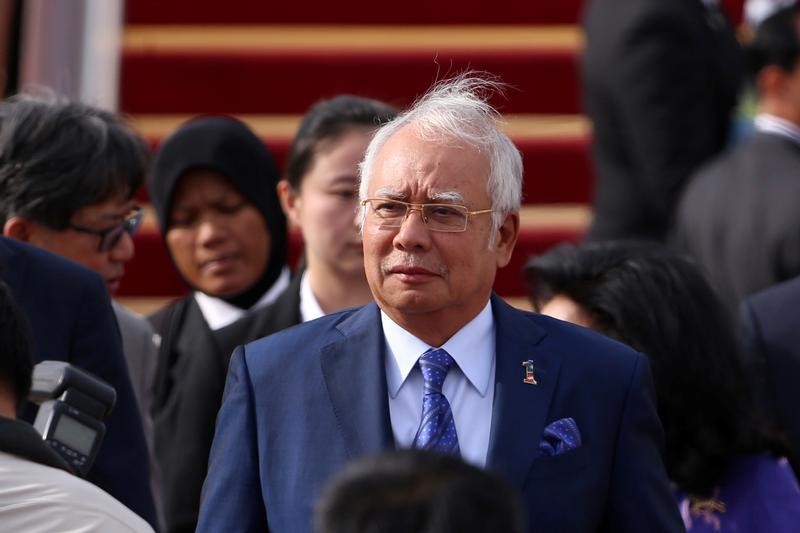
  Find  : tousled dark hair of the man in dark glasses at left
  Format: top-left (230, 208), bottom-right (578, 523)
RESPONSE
top-left (0, 95), bottom-right (149, 230)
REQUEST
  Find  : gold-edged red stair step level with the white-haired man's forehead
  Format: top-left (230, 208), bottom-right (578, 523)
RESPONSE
top-left (130, 115), bottom-right (593, 204)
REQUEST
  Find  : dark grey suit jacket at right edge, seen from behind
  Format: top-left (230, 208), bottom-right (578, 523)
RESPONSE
top-left (674, 133), bottom-right (800, 317)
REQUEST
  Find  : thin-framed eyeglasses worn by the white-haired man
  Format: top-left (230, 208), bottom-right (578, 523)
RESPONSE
top-left (361, 198), bottom-right (496, 233)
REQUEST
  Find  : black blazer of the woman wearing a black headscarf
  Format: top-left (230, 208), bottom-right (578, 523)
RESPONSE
top-left (150, 276), bottom-right (300, 533)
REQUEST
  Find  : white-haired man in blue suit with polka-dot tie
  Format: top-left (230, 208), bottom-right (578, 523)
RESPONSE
top-left (198, 75), bottom-right (682, 533)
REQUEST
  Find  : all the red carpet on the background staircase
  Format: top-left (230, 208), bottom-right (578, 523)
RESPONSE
top-left (120, 0), bottom-right (742, 297)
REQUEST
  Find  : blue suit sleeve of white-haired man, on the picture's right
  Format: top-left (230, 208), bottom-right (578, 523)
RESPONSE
top-left (603, 357), bottom-right (684, 533)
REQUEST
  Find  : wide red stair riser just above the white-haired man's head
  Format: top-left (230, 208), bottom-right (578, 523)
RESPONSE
top-left (120, 51), bottom-right (581, 114)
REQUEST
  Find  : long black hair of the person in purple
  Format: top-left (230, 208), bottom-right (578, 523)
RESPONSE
top-left (526, 242), bottom-right (783, 497)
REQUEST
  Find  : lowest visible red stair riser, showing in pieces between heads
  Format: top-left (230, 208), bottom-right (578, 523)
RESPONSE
top-left (118, 229), bottom-right (581, 297)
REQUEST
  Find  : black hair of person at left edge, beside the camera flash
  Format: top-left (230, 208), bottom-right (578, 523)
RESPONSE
top-left (0, 281), bottom-right (33, 411)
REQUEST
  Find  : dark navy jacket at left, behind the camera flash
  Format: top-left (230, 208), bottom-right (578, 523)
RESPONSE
top-left (0, 237), bottom-right (158, 527)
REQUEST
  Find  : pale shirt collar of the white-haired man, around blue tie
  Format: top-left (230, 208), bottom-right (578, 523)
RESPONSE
top-left (381, 302), bottom-right (495, 398)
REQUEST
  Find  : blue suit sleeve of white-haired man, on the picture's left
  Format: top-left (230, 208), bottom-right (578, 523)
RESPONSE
top-left (197, 346), bottom-right (268, 532)
